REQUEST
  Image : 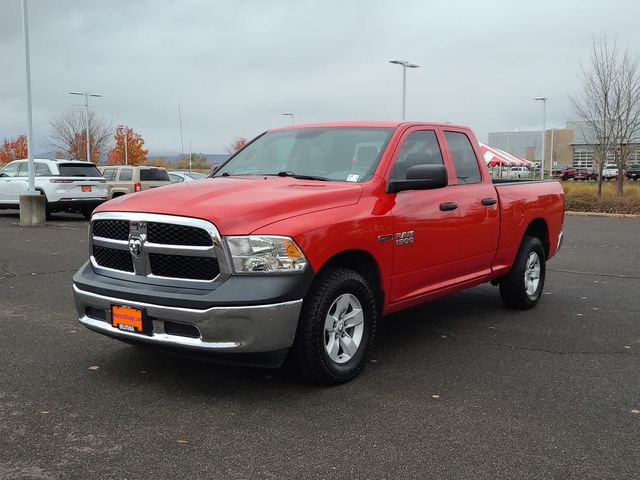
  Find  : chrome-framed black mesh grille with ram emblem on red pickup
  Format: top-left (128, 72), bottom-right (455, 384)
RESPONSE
top-left (90, 212), bottom-right (228, 284)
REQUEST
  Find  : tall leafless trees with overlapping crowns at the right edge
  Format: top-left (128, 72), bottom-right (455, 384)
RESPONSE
top-left (570, 36), bottom-right (640, 197)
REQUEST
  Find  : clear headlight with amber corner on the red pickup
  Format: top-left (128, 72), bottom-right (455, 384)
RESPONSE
top-left (225, 235), bottom-right (307, 273)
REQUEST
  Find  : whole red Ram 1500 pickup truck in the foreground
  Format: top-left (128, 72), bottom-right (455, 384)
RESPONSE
top-left (73, 122), bottom-right (564, 384)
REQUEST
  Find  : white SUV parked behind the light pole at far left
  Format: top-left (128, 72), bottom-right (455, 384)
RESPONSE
top-left (0, 158), bottom-right (107, 218)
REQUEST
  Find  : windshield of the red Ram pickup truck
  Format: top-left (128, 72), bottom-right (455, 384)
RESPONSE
top-left (214, 128), bottom-right (393, 182)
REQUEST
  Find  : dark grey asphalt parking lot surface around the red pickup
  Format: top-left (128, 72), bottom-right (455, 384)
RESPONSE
top-left (0, 212), bottom-right (640, 479)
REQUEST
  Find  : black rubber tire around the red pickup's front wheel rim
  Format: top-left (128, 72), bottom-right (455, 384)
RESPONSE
top-left (288, 268), bottom-right (378, 385)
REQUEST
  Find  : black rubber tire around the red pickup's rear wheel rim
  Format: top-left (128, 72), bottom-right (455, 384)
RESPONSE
top-left (500, 236), bottom-right (546, 310)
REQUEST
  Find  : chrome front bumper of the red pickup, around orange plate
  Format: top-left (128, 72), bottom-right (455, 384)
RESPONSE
top-left (73, 285), bottom-right (302, 353)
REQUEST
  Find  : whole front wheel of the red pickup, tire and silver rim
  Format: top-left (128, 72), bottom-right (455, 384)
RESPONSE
top-left (289, 268), bottom-right (378, 385)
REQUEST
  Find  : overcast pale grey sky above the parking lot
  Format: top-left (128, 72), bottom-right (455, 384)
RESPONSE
top-left (0, 0), bottom-right (640, 154)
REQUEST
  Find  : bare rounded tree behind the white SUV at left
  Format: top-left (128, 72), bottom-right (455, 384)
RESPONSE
top-left (49, 110), bottom-right (114, 163)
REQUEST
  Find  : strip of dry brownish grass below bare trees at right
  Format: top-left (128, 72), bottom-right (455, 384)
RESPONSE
top-left (560, 180), bottom-right (640, 214)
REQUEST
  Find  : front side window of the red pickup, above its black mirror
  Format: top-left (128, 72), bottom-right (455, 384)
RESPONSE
top-left (391, 130), bottom-right (443, 180)
